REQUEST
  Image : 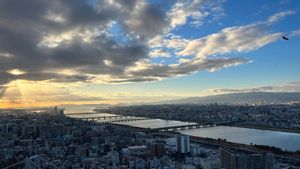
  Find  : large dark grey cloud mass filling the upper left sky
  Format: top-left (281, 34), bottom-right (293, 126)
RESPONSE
top-left (0, 0), bottom-right (166, 84)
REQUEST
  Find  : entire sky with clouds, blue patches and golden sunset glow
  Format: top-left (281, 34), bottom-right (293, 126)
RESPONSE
top-left (0, 0), bottom-right (300, 108)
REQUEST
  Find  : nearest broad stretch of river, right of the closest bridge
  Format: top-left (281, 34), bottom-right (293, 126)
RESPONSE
top-left (181, 126), bottom-right (300, 151)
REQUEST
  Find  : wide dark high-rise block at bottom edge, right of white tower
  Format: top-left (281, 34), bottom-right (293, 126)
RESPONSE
top-left (220, 148), bottom-right (274, 169)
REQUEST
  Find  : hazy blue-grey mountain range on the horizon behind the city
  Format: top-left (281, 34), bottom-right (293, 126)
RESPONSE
top-left (160, 92), bottom-right (300, 104)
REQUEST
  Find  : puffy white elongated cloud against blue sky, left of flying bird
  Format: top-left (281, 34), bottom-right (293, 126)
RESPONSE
top-left (177, 24), bottom-right (282, 59)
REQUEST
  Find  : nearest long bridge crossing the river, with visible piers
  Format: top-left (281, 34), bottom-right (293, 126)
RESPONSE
top-left (150, 124), bottom-right (216, 132)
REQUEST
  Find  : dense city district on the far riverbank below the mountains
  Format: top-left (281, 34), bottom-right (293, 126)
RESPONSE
top-left (98, 104), bottom-right (300, 132)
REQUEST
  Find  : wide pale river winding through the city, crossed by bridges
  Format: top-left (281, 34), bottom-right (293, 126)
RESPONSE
top-left (68, 108), bottom-right (300, 151)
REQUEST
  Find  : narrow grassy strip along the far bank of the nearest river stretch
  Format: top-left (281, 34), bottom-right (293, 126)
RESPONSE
top-left (228, 124), bottom-right (300, 134)
